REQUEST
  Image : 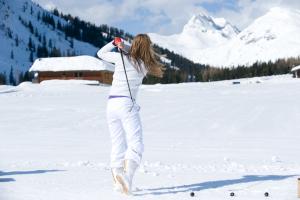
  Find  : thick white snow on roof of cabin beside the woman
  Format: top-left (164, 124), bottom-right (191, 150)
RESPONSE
top-left (29, 56), bottom-right (114, 71)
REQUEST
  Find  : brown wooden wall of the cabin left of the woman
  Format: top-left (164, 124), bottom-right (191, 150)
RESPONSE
top-left (38, 71), bottom-right (113, 84)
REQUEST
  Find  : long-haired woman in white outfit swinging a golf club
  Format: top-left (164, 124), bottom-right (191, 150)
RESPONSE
top-left (97, 34), bottom-right (163, 194)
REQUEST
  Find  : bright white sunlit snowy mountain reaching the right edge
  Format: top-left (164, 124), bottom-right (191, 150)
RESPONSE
top-left (151, 7), bottom-right (300, 66)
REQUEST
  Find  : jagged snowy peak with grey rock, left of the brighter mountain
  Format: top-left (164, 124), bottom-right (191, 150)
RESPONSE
top-left (149, 13), bottom-right (239, 60)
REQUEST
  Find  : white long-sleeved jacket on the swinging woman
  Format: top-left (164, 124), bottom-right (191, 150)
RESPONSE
top-left (97, 41), bottom-right (147, 99)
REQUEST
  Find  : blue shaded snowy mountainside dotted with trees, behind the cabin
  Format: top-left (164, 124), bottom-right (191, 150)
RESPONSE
top-left (0, 0), bottom-right (98, 80)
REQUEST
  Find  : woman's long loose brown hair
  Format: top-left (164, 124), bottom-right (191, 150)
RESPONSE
top-left (129, 34), bottom-right (164, 78)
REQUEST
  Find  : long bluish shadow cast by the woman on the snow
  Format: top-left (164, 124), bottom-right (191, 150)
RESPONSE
top-left (134, 175), bottom-right (296, 196)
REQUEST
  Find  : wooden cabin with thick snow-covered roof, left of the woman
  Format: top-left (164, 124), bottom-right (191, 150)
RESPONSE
top-left (29, 56), bottom-right (114, 84)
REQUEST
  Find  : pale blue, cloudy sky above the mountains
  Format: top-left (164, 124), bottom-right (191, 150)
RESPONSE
top-left (34, 0), bottom-right (300, 35)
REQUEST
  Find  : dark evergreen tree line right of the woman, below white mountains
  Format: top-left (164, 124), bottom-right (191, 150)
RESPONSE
top-left (144, 57), bottom-right (300, 84)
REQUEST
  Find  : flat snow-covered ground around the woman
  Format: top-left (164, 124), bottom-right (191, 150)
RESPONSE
top-left (0, 75), bottom-right (300, 200)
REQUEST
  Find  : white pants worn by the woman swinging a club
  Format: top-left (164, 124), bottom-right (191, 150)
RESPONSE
top-left (107, 97), bottom-right (144, 168)
